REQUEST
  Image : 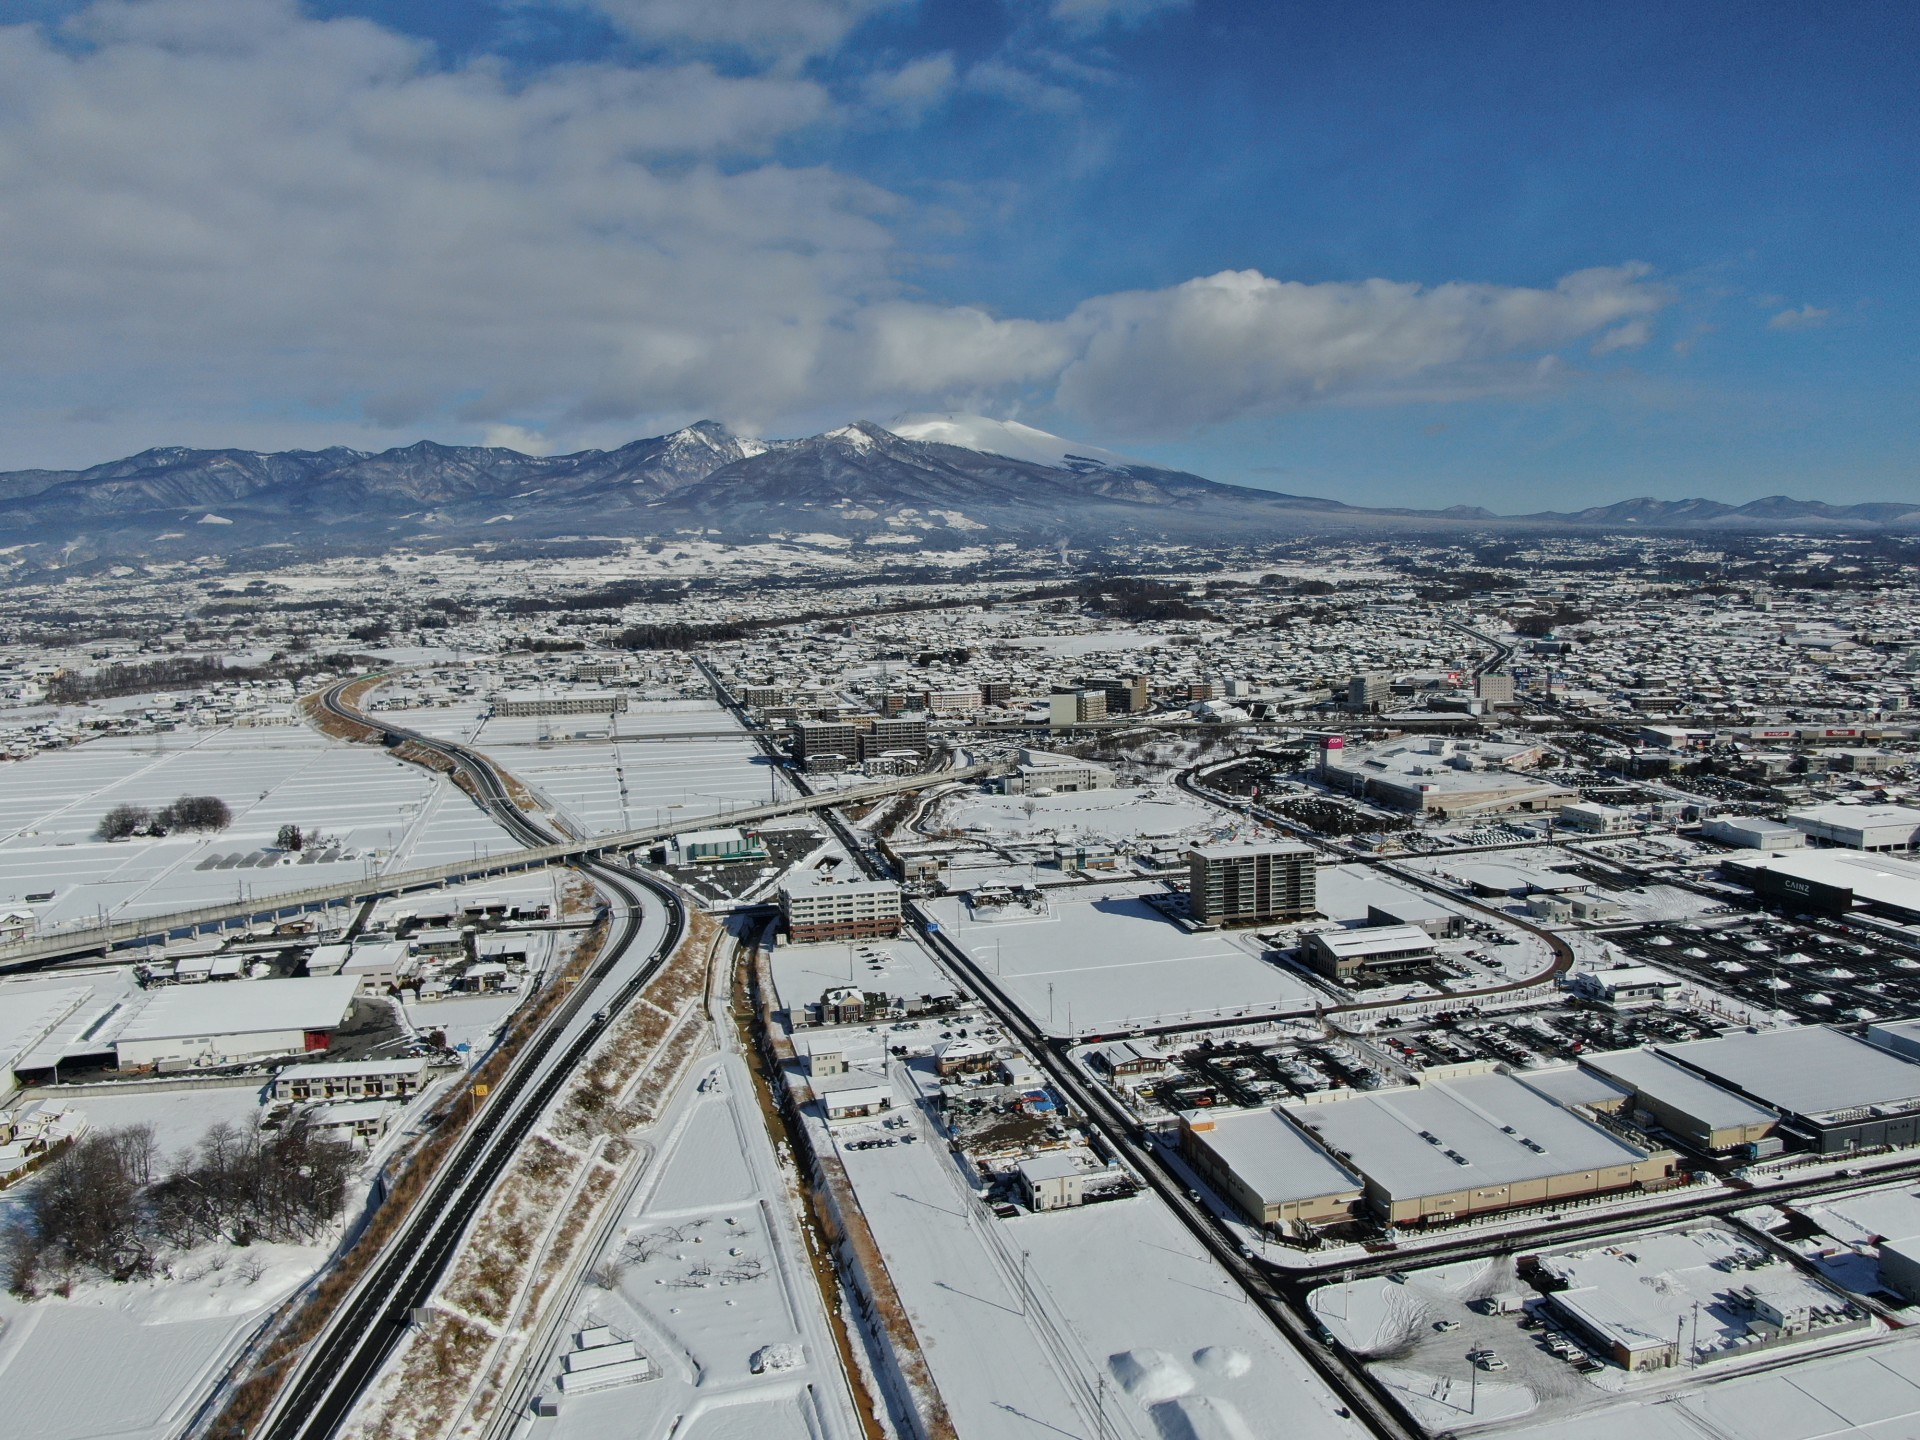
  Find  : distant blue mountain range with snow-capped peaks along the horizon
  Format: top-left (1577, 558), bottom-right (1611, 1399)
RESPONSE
top-left (0, 415), bottom-right (1920, 555)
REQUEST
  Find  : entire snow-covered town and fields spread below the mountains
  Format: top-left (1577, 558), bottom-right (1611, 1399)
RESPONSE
top-left (0, 526), bottom-right (1920, 1438)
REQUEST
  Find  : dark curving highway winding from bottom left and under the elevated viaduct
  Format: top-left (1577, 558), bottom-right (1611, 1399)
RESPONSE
top-left (257, 682), bottom-right (685, 1440)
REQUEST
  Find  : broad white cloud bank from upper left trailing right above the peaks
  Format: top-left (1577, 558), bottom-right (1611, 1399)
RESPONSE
top-left (0, 0), bottom-right (1665, 467)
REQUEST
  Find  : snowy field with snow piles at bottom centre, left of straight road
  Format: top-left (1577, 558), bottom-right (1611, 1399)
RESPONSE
top-left (816, 1064), bottom-right (1354, 1440)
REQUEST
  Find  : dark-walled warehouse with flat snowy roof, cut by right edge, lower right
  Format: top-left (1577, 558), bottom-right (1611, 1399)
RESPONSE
top-left (1657, 1025), bottom-right (1920, 1154)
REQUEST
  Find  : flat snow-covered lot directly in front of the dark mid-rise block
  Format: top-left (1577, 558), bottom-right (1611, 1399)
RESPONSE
top-left (927, 885), bottom-right (1325, 1035)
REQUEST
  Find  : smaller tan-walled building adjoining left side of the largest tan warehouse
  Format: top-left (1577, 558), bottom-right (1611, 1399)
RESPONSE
top-left (1181, 1108), bottom-right (1365, 1233)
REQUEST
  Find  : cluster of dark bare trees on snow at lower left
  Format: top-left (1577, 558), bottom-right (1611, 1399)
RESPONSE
top-left (8, 1116), bottom-right (355, 1296)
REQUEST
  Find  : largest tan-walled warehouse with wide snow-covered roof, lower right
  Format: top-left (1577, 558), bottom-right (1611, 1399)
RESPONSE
top-left (1286, 1069), bottom-right (1674, 1225)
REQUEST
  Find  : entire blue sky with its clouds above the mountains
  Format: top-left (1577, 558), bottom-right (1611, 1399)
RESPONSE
top-left (0, 0), bottom-right (1920, 511)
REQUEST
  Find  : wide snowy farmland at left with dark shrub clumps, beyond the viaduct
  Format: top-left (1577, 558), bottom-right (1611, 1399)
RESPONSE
top-left (0, 726), bottom-right (518, 933)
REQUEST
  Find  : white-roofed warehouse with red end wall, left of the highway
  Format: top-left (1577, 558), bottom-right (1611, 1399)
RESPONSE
top-left (113, 975), bottom-right (359, 1069)
